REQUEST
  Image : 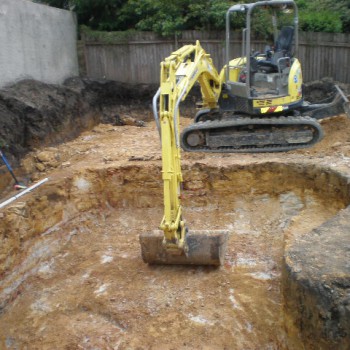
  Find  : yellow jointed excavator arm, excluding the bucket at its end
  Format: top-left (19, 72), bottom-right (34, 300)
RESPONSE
top-left (158, 41), bottom-right (221, 249)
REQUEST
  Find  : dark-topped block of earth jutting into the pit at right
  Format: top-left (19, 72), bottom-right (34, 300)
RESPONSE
top-left (283, 207), bottom-right (350, 350)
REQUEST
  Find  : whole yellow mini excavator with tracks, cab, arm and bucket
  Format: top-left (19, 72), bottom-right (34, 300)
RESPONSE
top-left (140, 0), bottom-right (350, 265)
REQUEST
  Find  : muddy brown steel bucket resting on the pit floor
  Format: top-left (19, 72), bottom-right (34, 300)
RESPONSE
top-left (140, 230), bottom-right (228, 266)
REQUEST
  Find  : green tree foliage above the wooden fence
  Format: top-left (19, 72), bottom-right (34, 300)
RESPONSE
top-left (36, 0), bottom-right (350, 35)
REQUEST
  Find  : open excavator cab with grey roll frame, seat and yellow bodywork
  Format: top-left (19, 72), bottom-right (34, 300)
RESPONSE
top-left (219, 0), bottom-right (302, 115)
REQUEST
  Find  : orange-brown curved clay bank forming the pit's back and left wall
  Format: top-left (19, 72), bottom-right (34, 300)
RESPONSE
top-left (0, 163), bottom-right (350, 300)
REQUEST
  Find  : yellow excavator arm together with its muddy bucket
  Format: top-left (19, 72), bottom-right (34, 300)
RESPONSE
top-left (140, 41), bottom-right (227, 265)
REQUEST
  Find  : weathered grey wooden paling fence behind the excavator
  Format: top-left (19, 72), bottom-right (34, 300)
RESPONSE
top-left (84, 31), bottom-right (350, 84)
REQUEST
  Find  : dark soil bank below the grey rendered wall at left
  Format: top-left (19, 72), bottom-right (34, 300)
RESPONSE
top-left (0, 78), bottom-right (155, 163)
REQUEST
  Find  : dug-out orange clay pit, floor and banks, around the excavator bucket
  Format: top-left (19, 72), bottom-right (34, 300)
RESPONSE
top-left (0, 156), bottom-right (350, 349)
